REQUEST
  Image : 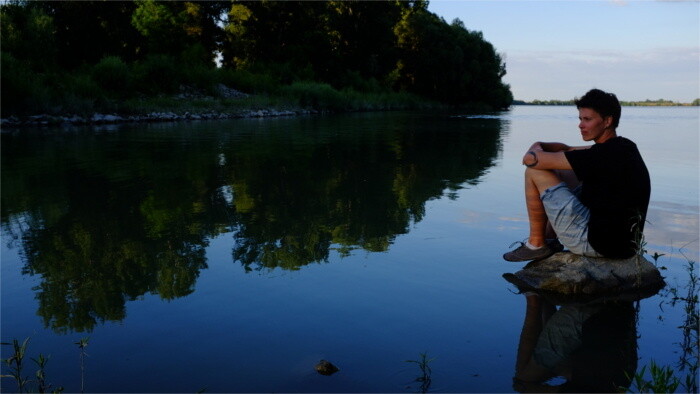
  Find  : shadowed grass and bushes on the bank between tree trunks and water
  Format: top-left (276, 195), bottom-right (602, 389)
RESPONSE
top-left (0, 53), bottom-right (445, 118)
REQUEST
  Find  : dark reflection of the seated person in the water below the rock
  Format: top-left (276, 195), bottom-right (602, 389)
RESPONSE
top-left (513, 294), bottom-right (637, 393)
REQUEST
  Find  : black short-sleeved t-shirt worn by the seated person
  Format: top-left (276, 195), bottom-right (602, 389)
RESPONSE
top-left (565, 137), bottom-right (651, 258)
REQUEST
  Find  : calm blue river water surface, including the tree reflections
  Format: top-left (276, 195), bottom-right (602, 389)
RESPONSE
top-left (1, 107), bottom-right (700, 392)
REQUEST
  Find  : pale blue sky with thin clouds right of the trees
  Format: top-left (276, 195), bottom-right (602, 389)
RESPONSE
top-left (428, 0), bottom-right (700, 102)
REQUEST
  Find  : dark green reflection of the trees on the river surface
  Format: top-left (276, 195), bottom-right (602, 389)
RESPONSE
top-left (1, 114), bottom-right (501, 331)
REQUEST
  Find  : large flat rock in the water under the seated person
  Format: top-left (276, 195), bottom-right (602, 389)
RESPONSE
top-left (503, 252), bottom-right (666, 302)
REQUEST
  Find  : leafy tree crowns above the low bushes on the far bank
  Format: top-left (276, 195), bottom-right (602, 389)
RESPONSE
top-left (0, 0), bottom-right (512, 108)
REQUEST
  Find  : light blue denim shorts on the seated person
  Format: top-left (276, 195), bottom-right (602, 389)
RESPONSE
top-left (540, 182), bottom-right (601, 257)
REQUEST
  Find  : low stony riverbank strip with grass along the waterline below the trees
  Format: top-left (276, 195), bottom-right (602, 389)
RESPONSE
top-left (0, 83), bottom-right (446, 128)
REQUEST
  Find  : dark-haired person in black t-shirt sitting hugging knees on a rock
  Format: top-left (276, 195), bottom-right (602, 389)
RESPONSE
top-left (503, 89), bottom-right (651, 261)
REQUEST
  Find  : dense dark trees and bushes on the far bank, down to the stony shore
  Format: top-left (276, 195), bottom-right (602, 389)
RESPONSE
top-left (0, 0), bottom-right (512, 116)
